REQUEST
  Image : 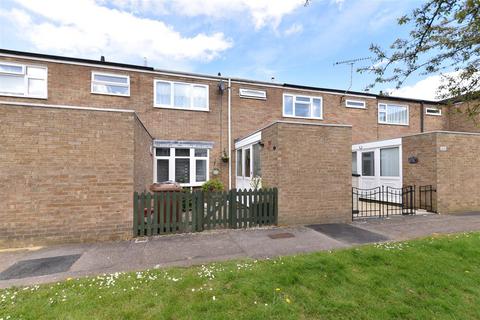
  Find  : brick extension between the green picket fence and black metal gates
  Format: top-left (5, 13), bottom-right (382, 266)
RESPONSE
top-left (261, 122), bottom-right (352, 224)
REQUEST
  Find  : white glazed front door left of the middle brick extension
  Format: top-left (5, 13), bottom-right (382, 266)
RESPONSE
top-left (235, 142), bottom-right (260, 189)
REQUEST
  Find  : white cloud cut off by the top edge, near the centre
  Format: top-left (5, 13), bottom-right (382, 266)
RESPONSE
top-left (105, 0), bottom-right (305, 29)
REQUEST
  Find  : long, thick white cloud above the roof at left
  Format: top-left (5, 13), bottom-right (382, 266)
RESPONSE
top-left (3, 0), bottom-right (233, 63)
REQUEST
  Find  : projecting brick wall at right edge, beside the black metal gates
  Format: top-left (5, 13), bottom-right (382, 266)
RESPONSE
top-left (402, 132), bottom-right (480, 213)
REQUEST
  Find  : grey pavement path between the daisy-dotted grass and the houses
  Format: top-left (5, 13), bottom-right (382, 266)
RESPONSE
top-left (0, 213), bottom-right (480, 288)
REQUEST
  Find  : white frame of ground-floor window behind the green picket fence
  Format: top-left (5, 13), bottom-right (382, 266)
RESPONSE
top-left (153, 146), bottom-right (210, 187)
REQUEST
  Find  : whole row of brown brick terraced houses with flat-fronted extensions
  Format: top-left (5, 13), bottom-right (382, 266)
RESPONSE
top-left (0, 50), bottom-right (480, 246)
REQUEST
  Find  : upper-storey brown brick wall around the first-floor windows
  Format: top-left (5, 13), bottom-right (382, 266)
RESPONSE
top-left (0, 57), bottom-right (452, 190)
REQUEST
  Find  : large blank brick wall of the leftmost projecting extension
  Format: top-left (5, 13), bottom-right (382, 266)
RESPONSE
top-left (0, 104), bottom-right (151, 247)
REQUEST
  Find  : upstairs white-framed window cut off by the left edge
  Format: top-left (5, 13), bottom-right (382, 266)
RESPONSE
top-left (0, 62), bottom-right (48, 98)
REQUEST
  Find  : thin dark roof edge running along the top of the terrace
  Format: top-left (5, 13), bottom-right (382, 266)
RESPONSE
top-left (0, 48), bottom-right (445, 105)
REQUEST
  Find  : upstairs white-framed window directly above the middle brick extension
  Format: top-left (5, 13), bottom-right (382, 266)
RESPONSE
top-left (283, 94), bottom-right (322, 119)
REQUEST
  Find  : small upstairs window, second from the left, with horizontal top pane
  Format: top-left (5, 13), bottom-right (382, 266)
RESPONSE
top-left (92, 72), bottom-right (130, 97)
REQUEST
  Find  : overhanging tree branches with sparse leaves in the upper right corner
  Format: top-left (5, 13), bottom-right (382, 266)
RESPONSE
top-left (358, 0), bottom-right (480, 117)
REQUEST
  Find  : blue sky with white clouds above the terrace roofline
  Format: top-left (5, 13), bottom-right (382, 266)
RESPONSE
top-left (0, 0), bottom-right (440, 99)
